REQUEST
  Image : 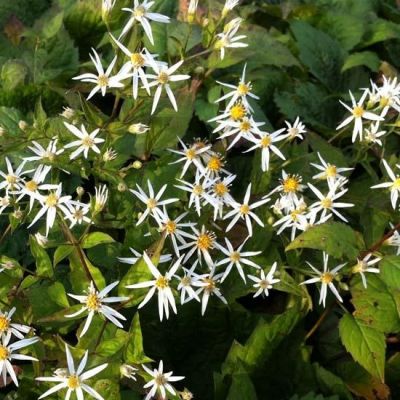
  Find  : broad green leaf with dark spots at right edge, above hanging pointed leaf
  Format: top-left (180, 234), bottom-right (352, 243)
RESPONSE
top-left (351, 272), bottom-right (400, 333)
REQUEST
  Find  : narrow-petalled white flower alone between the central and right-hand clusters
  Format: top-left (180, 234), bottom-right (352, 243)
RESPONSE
top-left (224, 183), bottom-right (270, 236)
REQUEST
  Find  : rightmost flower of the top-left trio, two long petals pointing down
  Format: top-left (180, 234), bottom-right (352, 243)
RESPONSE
top-left (147, 60), bottom-right (190, 114)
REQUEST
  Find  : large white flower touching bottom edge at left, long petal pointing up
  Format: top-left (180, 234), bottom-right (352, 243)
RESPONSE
top-left (36, 344), bottom-right (108, 400)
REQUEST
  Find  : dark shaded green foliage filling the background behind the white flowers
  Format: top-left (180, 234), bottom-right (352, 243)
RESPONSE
top-left (0, 0), bottom-right (400, 400)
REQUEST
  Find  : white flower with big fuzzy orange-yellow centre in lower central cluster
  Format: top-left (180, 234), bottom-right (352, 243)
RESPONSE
top-left (179, 225), bottom-right (216, 269)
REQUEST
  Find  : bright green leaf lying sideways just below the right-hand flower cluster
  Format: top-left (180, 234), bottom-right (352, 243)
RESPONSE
top-left (285, 222), bottom-right (364, 260)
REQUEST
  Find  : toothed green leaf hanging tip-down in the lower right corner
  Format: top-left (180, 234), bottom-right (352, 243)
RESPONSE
top-left (339, 314), bottom-right (386, 382)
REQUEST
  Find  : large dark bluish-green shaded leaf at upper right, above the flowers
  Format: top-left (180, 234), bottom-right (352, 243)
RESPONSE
top-left (291, 21), bottom-right (344, 90)
